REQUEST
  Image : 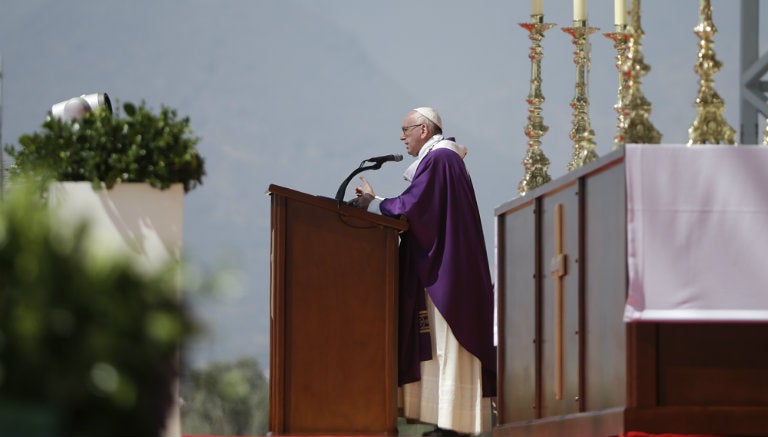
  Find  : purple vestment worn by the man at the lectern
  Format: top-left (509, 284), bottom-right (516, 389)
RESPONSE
top-left (379, 148), bottom-right (496, 396)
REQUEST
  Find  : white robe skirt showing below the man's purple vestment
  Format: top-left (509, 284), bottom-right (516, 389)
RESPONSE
top-left (401, 294), bottom-right (491, 434)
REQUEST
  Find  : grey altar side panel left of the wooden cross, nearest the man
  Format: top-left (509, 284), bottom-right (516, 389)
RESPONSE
top-left (497, 202), bottom-right (537, 423)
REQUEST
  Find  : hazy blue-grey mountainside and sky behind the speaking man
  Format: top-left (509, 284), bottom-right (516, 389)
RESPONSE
top-left (0, 0), bottom-right (768, 370)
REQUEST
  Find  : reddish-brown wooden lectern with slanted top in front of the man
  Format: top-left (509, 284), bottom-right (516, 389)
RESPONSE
top-left (269, 185), bottom-right (407, 435)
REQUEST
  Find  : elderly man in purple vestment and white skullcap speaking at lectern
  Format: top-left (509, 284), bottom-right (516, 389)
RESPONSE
top-left (353, 107), bottom-right (496, 436)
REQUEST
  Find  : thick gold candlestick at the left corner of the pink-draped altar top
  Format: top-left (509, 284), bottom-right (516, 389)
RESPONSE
top-left (622, 0), bottom-right (661, 144)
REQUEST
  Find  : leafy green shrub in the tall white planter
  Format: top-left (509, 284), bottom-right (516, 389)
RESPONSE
top-left (5, 102), bottom-right (205, 192)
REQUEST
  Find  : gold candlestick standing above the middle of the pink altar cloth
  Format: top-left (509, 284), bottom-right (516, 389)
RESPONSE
top-left (688, 0), bottom-right (736, 146)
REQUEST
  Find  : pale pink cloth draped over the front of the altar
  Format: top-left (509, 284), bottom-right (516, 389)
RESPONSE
top-left (624, 145), bottom-right (768, 322)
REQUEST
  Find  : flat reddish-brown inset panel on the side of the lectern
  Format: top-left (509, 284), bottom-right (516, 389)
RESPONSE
top-left (285, 202), bottom-right (394, 433)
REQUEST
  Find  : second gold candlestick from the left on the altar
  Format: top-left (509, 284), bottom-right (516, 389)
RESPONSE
top-left (562, 20), bottom-right (599, 171)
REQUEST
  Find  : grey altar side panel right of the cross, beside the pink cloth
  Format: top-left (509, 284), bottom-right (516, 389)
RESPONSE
top-left (582, 162), bottom-right (627, 411)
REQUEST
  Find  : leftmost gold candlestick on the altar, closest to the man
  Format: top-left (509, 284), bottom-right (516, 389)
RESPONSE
top-left (517, 14), bottom-right (555, 196)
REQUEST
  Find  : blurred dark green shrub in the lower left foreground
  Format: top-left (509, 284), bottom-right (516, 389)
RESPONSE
top-left (0, 185), bottom-right (198, 437)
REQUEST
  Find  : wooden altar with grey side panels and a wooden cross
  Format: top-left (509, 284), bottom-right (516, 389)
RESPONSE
top-left (494, 150), bottom-right (768, 437)
